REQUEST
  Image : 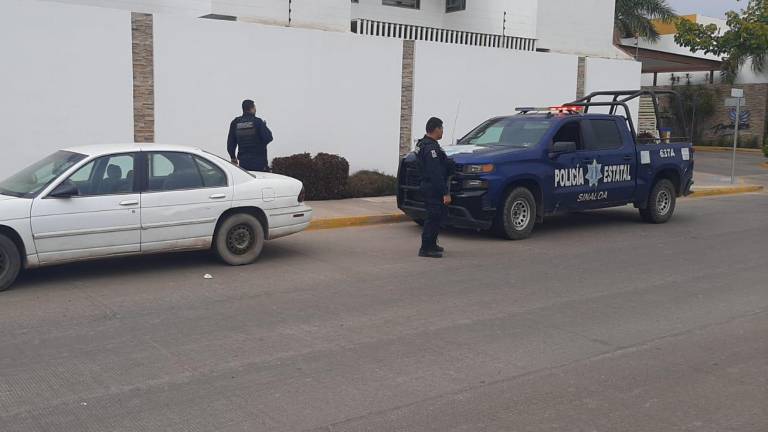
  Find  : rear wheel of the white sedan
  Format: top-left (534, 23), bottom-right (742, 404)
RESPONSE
top-left (213, 213), bottom-right (264, 266)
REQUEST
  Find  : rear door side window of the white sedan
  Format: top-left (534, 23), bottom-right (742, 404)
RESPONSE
top-left (148, 152), bottom-right (203, 192)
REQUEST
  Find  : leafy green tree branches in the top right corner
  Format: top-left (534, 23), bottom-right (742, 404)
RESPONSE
top-left (675, 0), bottom-right (768, 84)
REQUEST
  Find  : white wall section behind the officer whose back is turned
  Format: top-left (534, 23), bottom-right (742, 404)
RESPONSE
top-left (155, 16), bottom-right (402, 173)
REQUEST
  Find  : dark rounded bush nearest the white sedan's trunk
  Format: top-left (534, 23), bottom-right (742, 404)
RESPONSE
top-left (272, 153), bottom-right (349, 200)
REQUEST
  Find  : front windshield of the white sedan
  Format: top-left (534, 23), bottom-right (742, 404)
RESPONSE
top-left (0, 151), bottom-right (86, 198)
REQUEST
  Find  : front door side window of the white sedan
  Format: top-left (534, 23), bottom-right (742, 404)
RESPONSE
top-left (68, 154), bottom-right (134, 196)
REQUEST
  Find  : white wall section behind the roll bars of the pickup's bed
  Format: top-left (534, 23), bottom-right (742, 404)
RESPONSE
top-left (584, 58), bottom-right (642, 123)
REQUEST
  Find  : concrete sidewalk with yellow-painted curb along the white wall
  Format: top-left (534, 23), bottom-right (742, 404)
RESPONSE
top-left (307, 172), bottom-right (763, 230)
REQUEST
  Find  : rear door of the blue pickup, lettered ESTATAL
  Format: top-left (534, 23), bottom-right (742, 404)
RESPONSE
top-left (582, 117), bottom-right (637, 207)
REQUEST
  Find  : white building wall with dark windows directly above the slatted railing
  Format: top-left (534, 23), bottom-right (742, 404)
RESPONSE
top-left (352, 0), bottom-right (538, 38)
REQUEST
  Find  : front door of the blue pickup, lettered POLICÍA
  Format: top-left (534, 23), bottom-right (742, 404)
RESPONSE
top-left (550, 118), bottom-right (596, 211)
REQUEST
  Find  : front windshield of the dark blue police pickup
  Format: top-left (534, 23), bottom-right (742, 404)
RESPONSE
top-left (457, 116), bottom-right (552, 148)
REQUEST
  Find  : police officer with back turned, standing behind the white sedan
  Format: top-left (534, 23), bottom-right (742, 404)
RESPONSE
top-left (227, 99), bottom-right (273, 171)
